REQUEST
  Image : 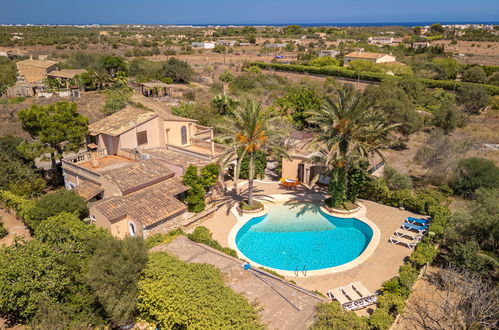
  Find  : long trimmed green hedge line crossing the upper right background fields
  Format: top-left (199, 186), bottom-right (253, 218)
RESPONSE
top-left (251, 62), bottom-right (499, 95)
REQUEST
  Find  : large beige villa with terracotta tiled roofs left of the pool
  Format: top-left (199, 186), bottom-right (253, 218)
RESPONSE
top-left (62, 106), bottom-right (223, 238)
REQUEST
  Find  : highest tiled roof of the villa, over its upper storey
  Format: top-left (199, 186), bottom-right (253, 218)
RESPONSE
top-left (88, 106), bottom-right (158, 136)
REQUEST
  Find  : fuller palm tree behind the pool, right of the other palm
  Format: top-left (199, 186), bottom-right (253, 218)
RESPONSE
top-left (310, 86), bottom-right (398, 206)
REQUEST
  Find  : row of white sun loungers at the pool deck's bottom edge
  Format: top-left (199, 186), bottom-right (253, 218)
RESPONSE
top-left (327, 281), bottom-right (377, 311)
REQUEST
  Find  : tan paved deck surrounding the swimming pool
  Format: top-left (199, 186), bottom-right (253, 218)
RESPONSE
top-left (202, 182), bottom-right (418, 300)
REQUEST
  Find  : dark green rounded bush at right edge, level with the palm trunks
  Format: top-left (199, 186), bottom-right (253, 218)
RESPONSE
top-left (450, 157), bottom-right (499, 198)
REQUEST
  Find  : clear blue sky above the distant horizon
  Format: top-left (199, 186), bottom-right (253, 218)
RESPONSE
top-left (0, 0), bottom-right (499, 24)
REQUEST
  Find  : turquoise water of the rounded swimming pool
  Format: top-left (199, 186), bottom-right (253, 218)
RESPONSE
top-left (236, 203), bottom-right (373, 271)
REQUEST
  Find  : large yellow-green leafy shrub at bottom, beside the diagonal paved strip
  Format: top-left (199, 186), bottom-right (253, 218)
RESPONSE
top-left (137, 252), bottom-right (263, 329)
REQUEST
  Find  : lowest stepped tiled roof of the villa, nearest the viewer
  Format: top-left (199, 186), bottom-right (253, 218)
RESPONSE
top-left (94, 178), bottom-right (188, 227)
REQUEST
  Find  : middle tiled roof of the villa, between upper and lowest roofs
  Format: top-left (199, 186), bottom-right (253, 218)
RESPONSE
top-left (102, 158), bottom-right (175, 195)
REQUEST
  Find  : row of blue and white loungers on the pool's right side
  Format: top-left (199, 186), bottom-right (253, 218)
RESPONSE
top-left (389, 217), bottom-right (431, 250)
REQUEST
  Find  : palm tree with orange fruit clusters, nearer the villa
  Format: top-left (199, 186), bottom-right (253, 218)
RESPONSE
top-left (221, 100), bottom-right (287, 207)
